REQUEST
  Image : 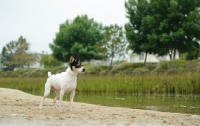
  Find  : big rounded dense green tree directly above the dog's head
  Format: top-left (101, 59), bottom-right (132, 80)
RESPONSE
top-left (50, 15), bottom-right (103, 62)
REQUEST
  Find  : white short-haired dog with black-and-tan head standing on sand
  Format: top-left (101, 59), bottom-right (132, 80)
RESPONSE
top-left (39, 55), bottom-right (86, 111)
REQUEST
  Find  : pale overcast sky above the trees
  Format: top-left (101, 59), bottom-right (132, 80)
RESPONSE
top-left (0, 0), bottom-right (128, 54)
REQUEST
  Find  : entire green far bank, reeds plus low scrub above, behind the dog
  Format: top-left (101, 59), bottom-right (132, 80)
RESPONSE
top-left (0, 59), bottom-right (200, 95)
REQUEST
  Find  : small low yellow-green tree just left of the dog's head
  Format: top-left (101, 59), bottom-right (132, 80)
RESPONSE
top-left (40, 55), bottom-right (63, 69)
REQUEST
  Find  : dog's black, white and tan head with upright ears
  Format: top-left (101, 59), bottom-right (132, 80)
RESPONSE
top-left (69, 55), bottom-right (86, 73)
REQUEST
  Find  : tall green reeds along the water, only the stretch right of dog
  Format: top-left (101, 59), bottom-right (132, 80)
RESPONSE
top-left (77, 73), bottom-right (200, 94)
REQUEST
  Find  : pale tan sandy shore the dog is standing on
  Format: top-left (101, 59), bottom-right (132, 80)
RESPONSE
top-left (0, 88), bottom-right (200, 126)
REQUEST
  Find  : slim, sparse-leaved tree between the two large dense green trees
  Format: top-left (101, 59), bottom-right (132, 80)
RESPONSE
top-left (103, 24), bottom-right (127, 67)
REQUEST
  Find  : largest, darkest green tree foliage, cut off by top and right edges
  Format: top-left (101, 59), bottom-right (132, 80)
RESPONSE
top-left (125, 0), bottom-right (200, 59)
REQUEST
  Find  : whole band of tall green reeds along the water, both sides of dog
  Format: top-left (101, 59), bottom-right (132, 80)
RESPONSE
top-left (0, 73), bottom-right (200, 95)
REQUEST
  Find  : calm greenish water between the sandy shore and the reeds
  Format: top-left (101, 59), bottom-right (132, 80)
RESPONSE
top-left (28, 92), bottom-right (200, 115)
